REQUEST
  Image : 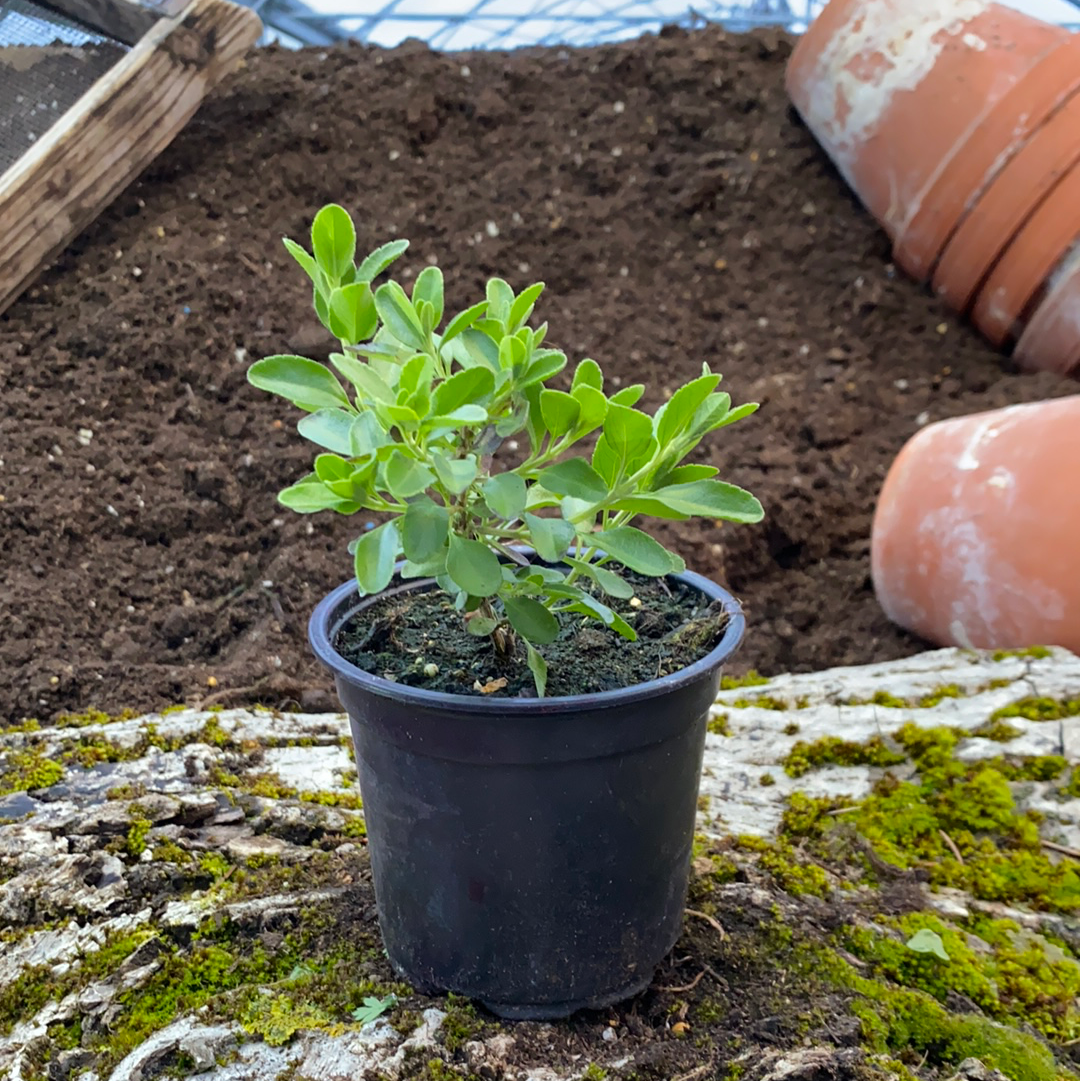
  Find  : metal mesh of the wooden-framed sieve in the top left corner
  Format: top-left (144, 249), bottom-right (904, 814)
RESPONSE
top-left (0, 0), bottom-right (128, 175)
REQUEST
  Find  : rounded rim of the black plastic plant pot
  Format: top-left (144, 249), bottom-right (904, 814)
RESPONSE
top-left (308, 563), bottom-right (746, 718)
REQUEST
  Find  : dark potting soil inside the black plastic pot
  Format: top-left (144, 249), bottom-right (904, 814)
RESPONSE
top-left (334, 574), bottom-right (729, 698)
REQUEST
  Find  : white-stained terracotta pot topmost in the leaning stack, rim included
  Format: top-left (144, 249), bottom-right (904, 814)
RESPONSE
top-left (787, 0), bottom-right (1076, 280)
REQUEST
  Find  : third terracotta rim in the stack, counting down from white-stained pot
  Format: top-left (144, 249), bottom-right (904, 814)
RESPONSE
top-left (972, 169), bottom-right (1080, 346)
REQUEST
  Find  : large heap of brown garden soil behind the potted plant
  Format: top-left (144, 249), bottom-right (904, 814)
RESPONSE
top-left (0, 28), bottom-right (1071, 723)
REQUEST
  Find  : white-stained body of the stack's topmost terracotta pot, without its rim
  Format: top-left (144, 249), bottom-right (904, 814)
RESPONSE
top-left (787, 0), bottom-right (1071, 248)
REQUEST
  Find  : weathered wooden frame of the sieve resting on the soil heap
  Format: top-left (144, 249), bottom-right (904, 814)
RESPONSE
top-left (0, 0), bottom-right (262, 312)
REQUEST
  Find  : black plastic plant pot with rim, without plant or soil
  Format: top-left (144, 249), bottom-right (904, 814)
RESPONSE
top-left (308, 573), bottom-right (746, 1019)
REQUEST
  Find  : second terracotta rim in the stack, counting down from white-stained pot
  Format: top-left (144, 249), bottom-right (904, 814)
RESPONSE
top-left (934, 85), bottom-right (1080, 312)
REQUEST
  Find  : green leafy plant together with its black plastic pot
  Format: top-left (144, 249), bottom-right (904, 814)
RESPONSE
top-left (249, 205), bottom-right (762, 1018)
